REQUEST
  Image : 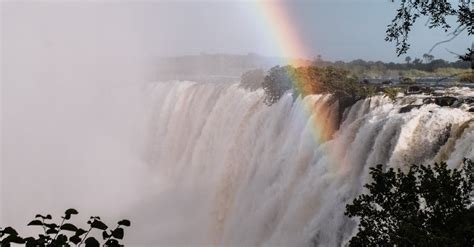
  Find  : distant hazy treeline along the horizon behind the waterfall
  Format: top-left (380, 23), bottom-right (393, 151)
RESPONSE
top-left (156, 53), bottom-right (472, 81)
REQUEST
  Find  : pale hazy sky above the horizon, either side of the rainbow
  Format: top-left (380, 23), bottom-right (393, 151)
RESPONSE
top-left (2, 0), bottom-right (472, 61)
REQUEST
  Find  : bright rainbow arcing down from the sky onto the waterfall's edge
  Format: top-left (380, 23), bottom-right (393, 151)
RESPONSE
top-left (257, 1), bottom-right (334, 144)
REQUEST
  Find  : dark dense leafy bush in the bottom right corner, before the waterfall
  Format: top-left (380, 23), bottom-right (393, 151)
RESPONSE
top-left (345, 159), bottom-right (474, 246)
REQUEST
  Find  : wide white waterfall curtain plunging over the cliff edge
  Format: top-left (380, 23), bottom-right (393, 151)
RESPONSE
top-left (130, 82), bottom-right (474, 246)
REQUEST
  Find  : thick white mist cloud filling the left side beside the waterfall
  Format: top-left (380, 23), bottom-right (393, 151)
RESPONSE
top-left (0, 2), bottom-right (157, 229)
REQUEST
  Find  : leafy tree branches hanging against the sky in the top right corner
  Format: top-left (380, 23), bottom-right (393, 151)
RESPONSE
top-left (385, 0), bottom-right (474, 61)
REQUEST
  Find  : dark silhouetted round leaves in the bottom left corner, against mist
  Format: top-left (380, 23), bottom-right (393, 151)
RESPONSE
top-left (0, 208), bottom-right (130, 247)
